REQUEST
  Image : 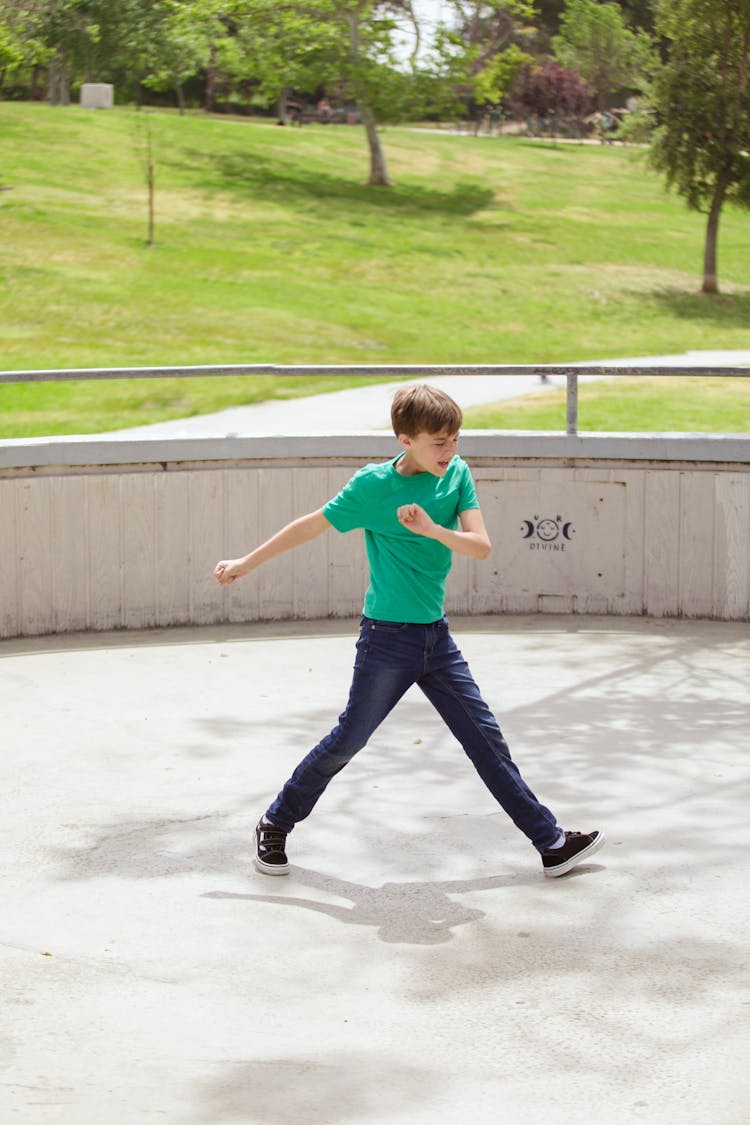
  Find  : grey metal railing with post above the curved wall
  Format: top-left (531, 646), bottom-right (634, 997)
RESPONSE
top-left (0, 363), bottom-right (750, 435)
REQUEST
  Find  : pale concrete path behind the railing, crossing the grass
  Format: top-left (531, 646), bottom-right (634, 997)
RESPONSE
top-left (104, 350), bottom-right (750, 439)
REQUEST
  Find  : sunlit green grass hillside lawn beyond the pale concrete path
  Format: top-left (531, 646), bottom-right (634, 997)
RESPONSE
top-left (0, 102), bottom-right (750, 437)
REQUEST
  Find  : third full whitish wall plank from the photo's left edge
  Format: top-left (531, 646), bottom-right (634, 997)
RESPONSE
top-left (85, 474), bottom-right (125, 629)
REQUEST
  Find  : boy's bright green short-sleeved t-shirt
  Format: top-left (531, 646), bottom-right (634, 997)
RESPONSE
top-left (323, 453), bottom-right (479, 624)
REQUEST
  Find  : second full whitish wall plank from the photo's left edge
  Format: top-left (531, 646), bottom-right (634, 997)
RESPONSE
top-left (51, 477), bottom-right (89, 632)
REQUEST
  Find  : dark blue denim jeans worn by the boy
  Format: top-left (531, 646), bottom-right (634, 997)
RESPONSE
top-left (266, 618), bottom-right (560, 852)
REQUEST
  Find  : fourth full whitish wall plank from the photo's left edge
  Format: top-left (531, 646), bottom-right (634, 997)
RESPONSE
top-left (120, 473), bottom-right (156, 629)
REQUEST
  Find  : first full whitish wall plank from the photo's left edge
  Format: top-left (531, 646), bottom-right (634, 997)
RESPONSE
top-left (17, 477), bottom-right (55, 636)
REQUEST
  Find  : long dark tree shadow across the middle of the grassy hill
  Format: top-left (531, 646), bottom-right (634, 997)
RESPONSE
top-left (170, 151), bottom-right (495, 218)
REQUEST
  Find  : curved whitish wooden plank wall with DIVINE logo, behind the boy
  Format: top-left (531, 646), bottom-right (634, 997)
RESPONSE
top-left (0, 436), bottom-right (750, 637)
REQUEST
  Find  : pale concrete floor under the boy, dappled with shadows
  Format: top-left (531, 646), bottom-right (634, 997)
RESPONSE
top-left (0, 617), bottom-right (750, 1125)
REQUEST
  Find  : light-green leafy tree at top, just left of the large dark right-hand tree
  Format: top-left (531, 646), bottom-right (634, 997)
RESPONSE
top-left (552, 0), bottom-right (653, 113)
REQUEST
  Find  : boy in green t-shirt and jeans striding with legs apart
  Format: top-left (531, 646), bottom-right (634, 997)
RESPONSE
top-left (214, 385), bottom-right (604, 876)
